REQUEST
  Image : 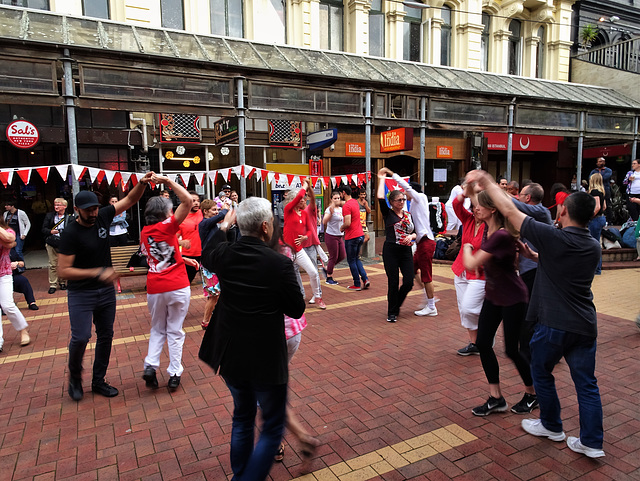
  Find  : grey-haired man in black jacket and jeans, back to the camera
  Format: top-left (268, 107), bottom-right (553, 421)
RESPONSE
top-left (200, 197), bottom-right (305, 481)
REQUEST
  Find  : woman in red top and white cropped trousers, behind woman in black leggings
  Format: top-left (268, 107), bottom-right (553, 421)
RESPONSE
top-left (451, 185), bottom-right (491, 356)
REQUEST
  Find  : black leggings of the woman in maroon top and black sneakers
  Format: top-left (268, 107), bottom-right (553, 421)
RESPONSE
top-left (476, 299), bottom-right (533, 386)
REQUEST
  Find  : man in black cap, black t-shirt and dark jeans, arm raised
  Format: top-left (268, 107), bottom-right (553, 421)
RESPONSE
top-left (58, 172), bottom-right (153, 401)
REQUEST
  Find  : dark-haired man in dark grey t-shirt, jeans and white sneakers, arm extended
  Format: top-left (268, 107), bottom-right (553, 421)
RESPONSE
top-left (467, 171), bottom-right (604, 458)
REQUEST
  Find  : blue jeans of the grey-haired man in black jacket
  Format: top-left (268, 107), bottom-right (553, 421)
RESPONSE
top-left (224, 378), bottom-right (287, 481)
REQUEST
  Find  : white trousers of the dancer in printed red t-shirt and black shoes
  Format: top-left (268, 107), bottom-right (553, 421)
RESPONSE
top-left (144, 287), bottom-right (191, 376)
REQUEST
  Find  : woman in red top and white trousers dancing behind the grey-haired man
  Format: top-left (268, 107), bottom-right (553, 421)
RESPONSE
top-left (282, 181), bottom-right (327, 309)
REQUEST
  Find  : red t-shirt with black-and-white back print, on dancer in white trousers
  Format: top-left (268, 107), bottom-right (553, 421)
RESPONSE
top-left (140, 216), bottom-right (189, 294)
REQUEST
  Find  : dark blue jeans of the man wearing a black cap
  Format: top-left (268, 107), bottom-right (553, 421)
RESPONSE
top-left (67, 285), bottom-right (116, 384)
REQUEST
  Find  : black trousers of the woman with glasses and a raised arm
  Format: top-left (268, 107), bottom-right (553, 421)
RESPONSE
top-left (382, 242), bottom-right (413, 316)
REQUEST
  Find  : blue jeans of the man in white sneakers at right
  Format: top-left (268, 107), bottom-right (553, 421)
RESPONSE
top-left (530, 324), bottom-right (604, 449)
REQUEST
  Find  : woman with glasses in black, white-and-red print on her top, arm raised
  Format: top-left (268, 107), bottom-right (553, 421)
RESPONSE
top-left (378, 171), bottom-right (416, 322)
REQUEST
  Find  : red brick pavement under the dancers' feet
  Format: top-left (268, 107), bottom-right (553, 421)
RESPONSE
top-left (0, 265), bottom-right (640, 481)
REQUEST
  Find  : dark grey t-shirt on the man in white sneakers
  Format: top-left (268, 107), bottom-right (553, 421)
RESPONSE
top-left (520, 217), bottom-right (602, 337)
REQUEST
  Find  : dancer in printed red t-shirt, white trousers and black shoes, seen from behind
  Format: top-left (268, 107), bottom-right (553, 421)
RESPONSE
top-left (140, 175), bottom-right (197, 390)
